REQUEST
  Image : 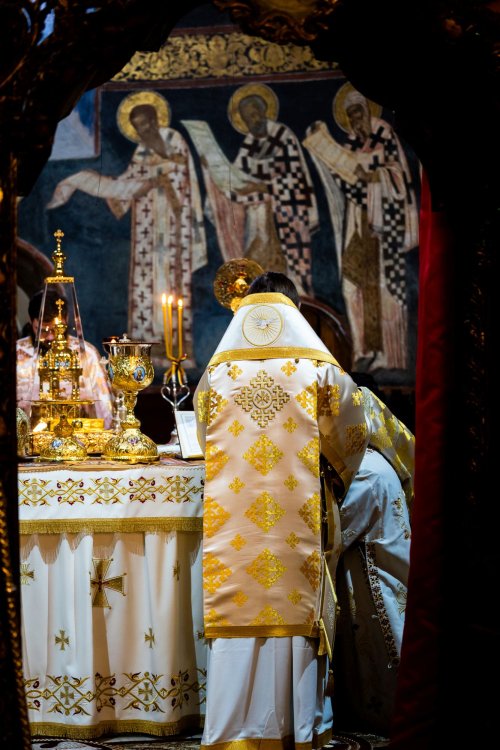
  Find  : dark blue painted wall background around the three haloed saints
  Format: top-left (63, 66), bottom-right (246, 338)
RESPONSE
top-left (18, 5), bottom-right (419, 402)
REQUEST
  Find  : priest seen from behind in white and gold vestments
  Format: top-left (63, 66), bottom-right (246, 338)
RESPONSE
top-left (195, 273), bottom-right (368, 750)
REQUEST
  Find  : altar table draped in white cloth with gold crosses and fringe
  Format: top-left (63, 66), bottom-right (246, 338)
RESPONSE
top-left (19, 458), bottom-right (206, 739)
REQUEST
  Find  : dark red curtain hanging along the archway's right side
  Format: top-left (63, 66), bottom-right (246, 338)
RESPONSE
top-left (390, 174), bottom-right (453, 750)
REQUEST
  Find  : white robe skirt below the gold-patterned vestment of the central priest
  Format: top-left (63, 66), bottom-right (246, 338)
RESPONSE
top-left (201, 636), bottom-right (332, 750)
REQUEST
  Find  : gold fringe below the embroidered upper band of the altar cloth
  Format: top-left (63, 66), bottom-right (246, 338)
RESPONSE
top-left (19, 518), bottom-right (203, 535)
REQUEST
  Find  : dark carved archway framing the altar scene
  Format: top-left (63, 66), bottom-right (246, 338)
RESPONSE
top-left (0, 0), bottom-right (500, 750)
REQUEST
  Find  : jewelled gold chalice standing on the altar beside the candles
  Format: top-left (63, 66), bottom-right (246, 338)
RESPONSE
top-left (102, 333), bottom-right (159, 463)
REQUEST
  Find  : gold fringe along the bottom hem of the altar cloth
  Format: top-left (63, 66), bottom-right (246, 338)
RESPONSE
top-left (30, 714), bottom-right (205, 747)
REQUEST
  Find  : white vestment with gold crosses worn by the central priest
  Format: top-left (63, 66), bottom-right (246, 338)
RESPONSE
top-left (195, 294), bottom-right (368, 638)
